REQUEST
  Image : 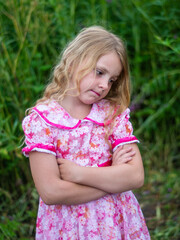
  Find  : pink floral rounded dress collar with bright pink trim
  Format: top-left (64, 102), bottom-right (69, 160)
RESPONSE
top-left (33, 99), bottom-right (114, 129)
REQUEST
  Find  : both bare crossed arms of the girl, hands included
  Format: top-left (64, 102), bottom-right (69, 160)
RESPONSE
top-left (29, 143), bottom-right (144, 205)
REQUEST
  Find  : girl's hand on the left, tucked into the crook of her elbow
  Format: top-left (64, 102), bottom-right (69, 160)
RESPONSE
top-left (57, 158), bottom-right (81, 183)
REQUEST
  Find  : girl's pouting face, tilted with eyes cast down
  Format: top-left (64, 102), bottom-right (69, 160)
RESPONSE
top-left (76, 52), bottom-right (122, 105)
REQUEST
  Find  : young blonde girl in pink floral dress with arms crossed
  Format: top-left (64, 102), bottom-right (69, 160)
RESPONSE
top-left (22, 26), bottom-right (150, 240)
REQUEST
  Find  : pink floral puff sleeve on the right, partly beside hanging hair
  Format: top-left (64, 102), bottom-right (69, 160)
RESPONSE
top-left (109, 108), bottom-right (139, 152)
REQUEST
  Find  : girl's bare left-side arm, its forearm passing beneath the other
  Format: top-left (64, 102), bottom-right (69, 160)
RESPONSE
top-left (29, 152), bottom-right (107, 205)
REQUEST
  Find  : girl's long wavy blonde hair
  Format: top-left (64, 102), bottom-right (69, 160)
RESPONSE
top-left (37, 26), bottom-right (130, 112)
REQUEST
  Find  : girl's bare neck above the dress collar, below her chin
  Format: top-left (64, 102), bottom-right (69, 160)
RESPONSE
top-left (60, 96), bottom-right (92, 120)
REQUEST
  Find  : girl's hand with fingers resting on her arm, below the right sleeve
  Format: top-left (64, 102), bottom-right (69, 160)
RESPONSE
top-left (112, 146), bottom-right (135, 166)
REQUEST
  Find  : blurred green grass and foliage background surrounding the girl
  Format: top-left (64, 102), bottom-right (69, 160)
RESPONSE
top-left (0, 0), bottom-right (180, 240)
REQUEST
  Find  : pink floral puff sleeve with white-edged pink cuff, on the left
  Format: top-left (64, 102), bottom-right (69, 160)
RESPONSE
top-left (22, 112), bottom-right (56, 157)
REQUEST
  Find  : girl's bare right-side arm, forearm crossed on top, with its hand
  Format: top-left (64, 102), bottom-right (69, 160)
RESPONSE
top-left (58, 143), bottom-right (144, 193)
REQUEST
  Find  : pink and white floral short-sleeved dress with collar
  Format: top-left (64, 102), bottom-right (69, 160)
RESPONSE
top-left (22, 100), bottom-right (150, 240)
